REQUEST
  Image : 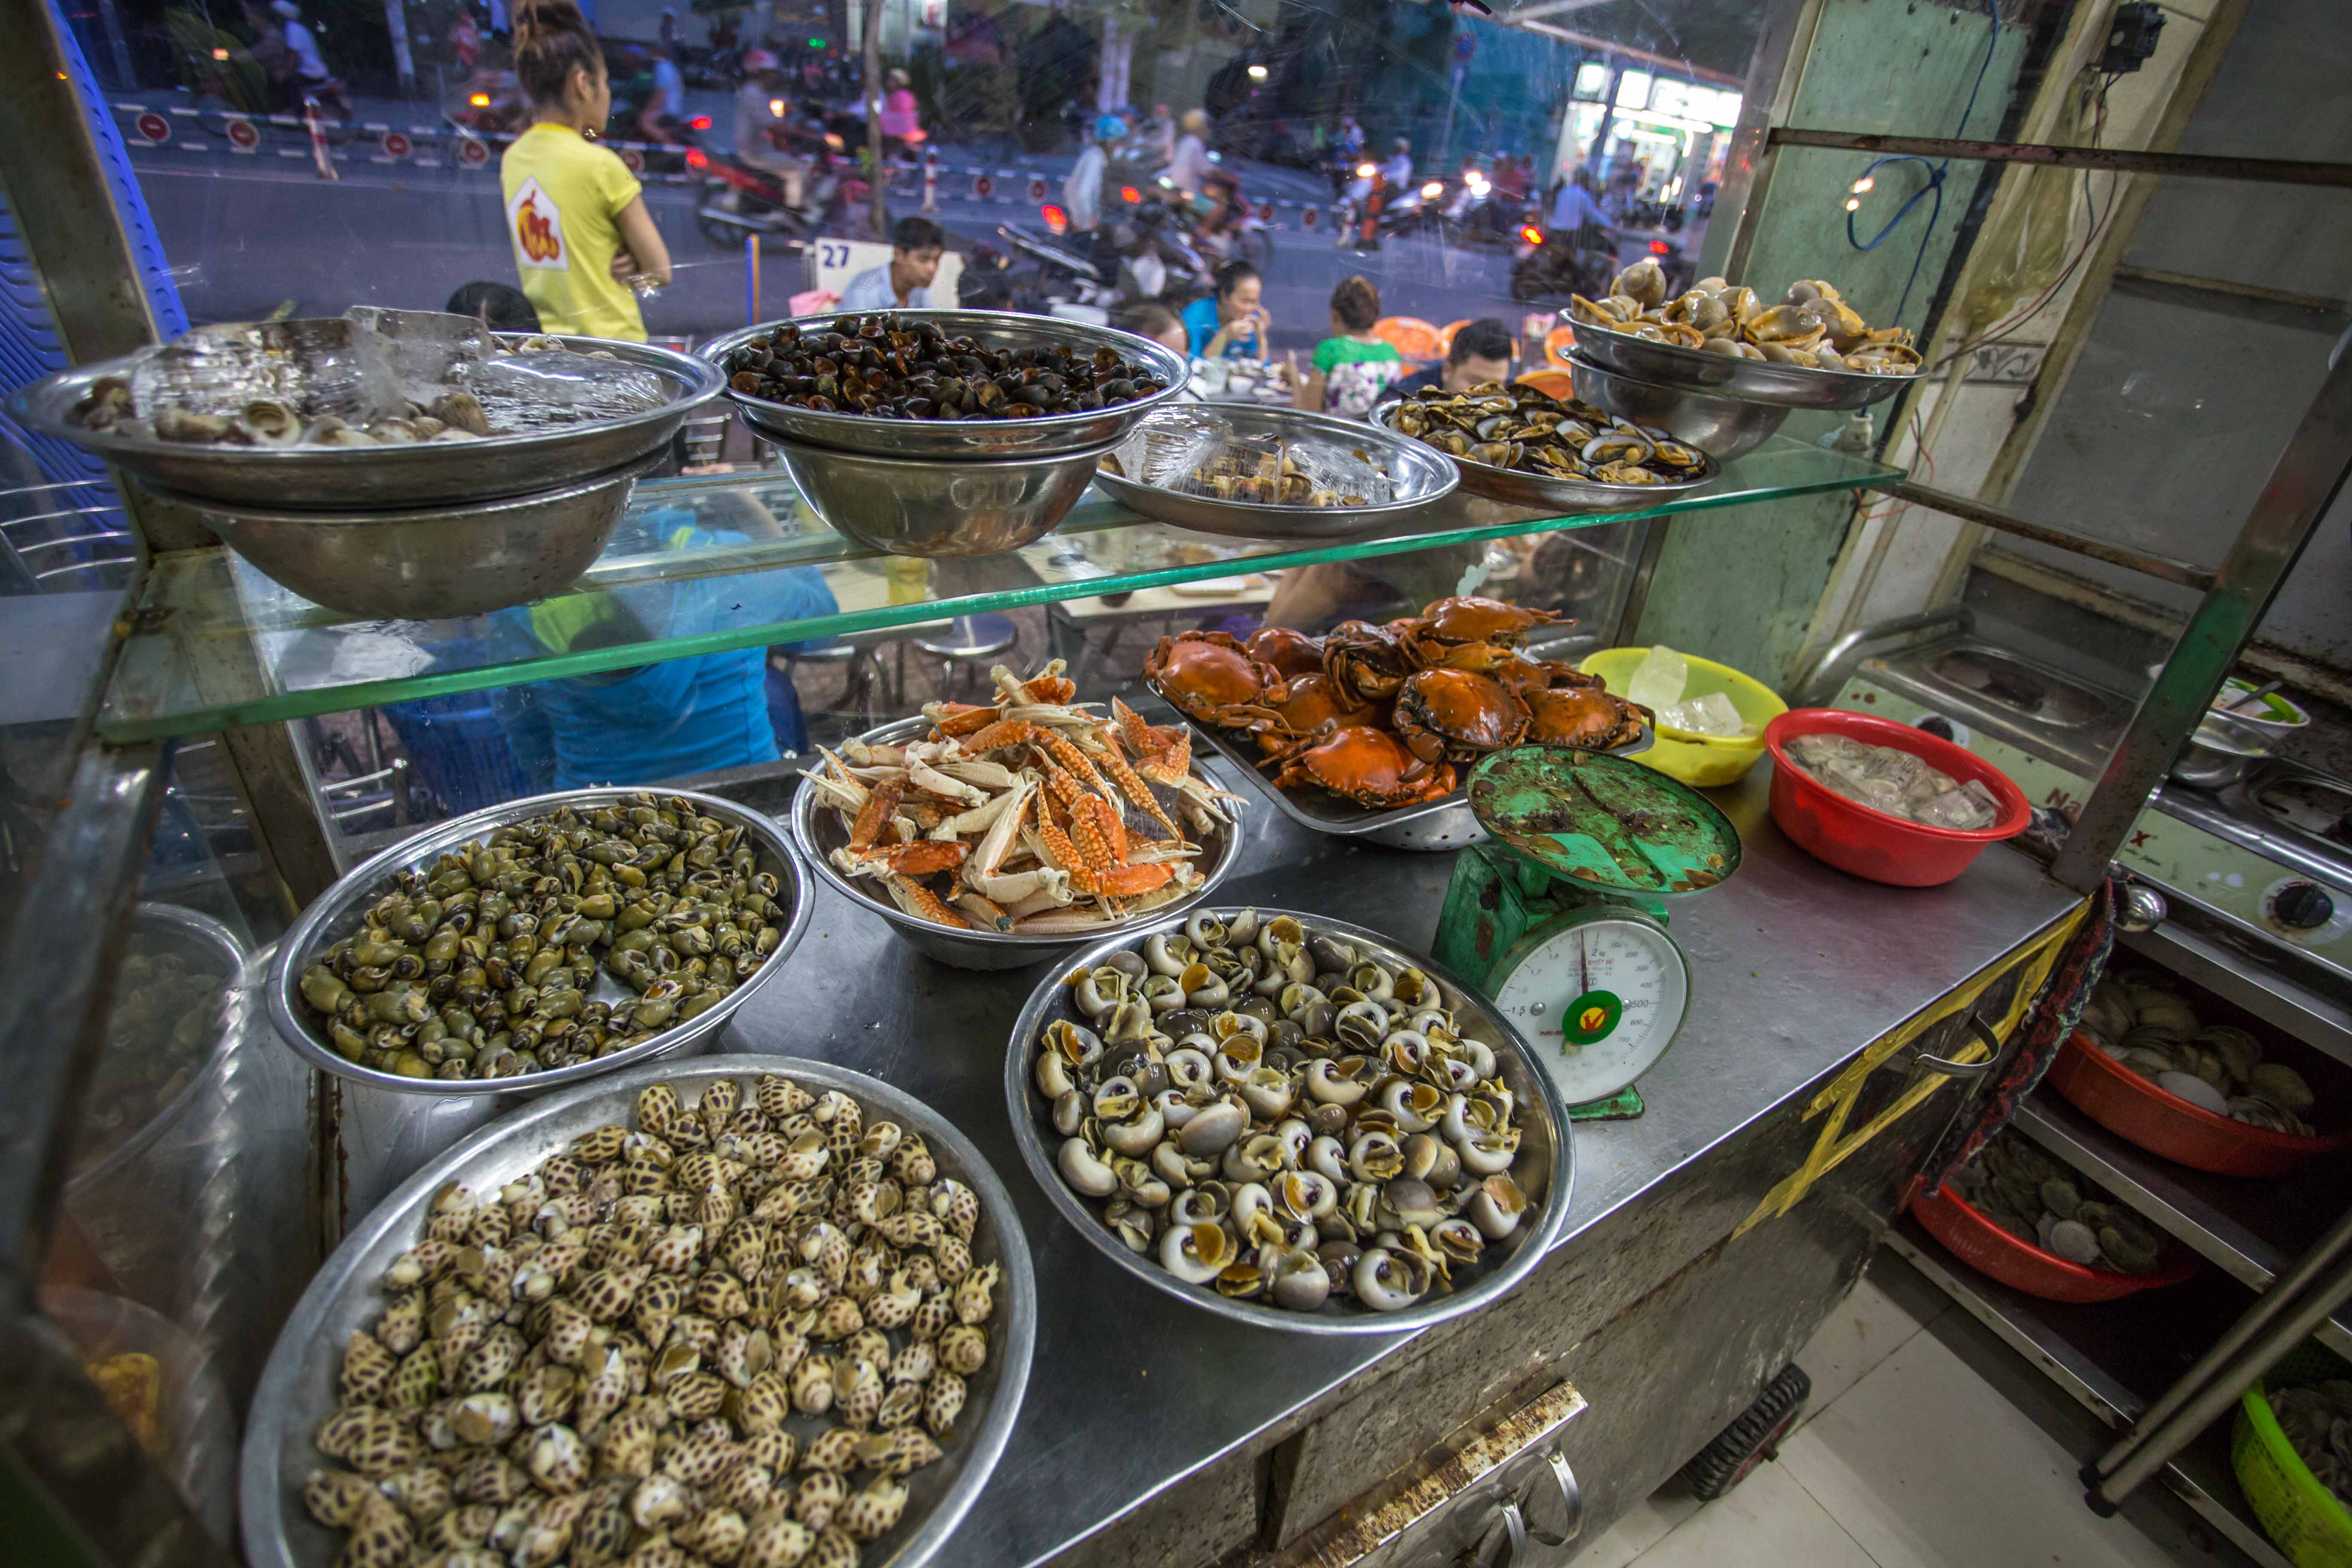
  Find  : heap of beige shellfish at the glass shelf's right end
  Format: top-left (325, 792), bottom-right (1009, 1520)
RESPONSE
top-left (1569, 256), bottom-right (1922, 376)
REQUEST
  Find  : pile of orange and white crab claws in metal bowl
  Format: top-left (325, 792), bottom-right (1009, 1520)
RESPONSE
top-left (807, 658), bottom-right (1240, 936)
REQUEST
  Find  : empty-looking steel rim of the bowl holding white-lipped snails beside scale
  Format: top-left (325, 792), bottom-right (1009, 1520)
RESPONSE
top-left (1004, 907), bottom-right (1576, 1333)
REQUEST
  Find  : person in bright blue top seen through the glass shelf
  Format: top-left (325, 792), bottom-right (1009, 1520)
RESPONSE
top-left (494, 503), bottom-right (837, 790)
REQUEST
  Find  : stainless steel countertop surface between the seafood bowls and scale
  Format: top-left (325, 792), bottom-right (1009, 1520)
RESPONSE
top-left (717, 764), bottom-right (2072, 1568)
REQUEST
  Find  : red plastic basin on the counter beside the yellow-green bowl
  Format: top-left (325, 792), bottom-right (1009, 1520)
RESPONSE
top-left (1764, 707), bottom-right (2034, 886)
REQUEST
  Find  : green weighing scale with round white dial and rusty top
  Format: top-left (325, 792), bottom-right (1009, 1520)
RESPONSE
top-left (1437, 745), bottom-right (1740, 1121)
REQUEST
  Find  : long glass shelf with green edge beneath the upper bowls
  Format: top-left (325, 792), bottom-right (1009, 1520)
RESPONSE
top-left (96, 437), bottom-right (1903, 743)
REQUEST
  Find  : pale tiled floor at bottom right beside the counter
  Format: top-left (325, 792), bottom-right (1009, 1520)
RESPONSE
top-left (1576, 1253), bottom-right (2244, 1568)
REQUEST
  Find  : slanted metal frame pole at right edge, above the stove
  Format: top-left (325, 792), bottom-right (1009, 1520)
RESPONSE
top-left (2051, 355), bottom-right (2352, 893)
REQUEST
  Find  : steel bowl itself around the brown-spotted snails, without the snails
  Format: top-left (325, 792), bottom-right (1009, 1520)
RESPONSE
top-left (238, 1056), bottom-right (1037, 1568)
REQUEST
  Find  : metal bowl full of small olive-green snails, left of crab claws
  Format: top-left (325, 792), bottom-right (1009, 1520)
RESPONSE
top-left (266, 787), bottom-right (812, 1098)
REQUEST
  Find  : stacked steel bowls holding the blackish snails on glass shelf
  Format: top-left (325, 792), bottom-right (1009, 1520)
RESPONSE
top-left (701, 310), bottom-right (1190, 557)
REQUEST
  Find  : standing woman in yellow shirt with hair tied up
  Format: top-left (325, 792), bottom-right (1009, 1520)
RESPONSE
top-left (499, 0), bottom-right (671, 343)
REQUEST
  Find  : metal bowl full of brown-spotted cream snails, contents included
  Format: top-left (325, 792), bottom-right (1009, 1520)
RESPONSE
top-left (238, 1056), bottom-right (1037, 1568)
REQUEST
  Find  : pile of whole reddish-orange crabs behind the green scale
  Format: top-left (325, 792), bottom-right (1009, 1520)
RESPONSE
top-left (1143, 597), bottom-right (1651, 806)
